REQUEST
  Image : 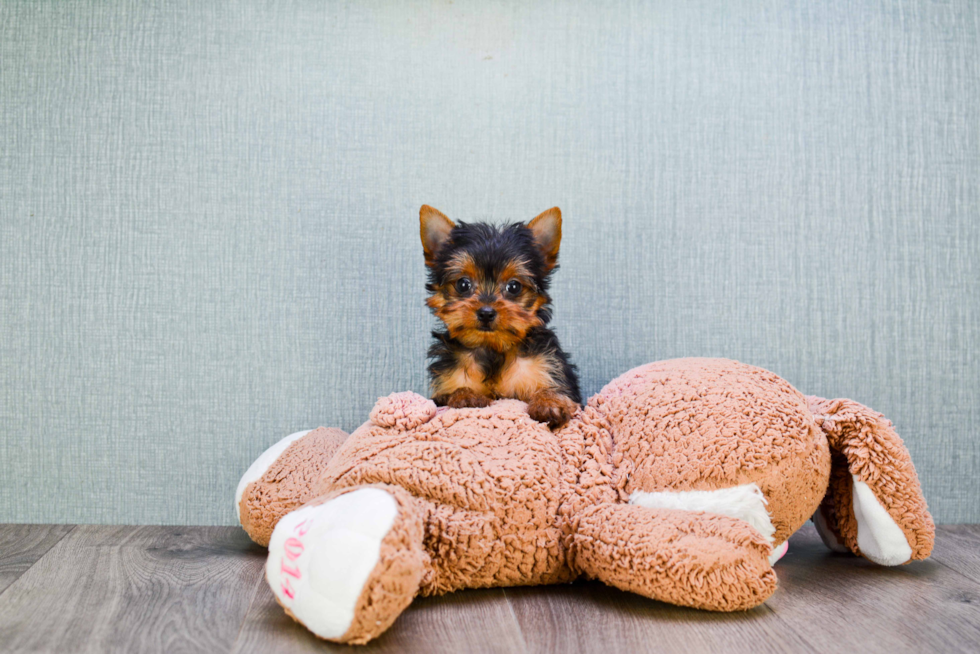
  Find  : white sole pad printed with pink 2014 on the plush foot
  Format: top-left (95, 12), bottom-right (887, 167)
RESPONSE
top-left (265, 488), bottom-right (398, 638)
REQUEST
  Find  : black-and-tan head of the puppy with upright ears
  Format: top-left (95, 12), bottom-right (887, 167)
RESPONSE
top-left (419, 205), bottom-right (561, 352)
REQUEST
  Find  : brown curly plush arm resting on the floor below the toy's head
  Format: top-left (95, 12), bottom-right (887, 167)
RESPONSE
top-left (573, 504), bottom-right (776, 611)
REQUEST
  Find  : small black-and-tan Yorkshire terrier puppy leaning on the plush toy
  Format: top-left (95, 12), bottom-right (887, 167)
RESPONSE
top-left (419, 205), bottom-right (582, 429)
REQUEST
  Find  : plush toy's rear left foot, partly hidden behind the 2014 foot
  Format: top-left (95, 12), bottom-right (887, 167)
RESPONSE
top-left (235, 427), bottom-right (347, 545)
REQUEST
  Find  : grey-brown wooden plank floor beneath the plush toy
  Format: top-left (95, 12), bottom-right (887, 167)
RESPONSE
top-left (0, 525), bottom-right (980, 654)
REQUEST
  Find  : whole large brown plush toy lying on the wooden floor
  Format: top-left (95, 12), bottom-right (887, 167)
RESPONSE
top-left (236, 359), bottom-right (934, 643)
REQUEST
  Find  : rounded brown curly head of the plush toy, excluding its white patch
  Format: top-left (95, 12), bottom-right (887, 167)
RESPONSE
top-left (589, 359), bottom-right (830, 545)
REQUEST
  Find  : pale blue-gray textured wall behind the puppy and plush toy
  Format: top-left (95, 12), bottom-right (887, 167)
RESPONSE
top-left (0, 0), bottom-right (980, 523)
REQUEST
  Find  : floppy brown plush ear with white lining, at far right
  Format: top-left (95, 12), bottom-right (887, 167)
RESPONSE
top-left (808, 397), bottom-right (935, 565)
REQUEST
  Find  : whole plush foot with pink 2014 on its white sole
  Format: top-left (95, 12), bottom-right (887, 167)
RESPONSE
top-left (266, 486), bottom-right (428, 643)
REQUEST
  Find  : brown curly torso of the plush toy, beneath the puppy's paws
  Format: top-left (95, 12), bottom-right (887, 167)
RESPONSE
top-left (316, 400), bottom-right (571, 595)
